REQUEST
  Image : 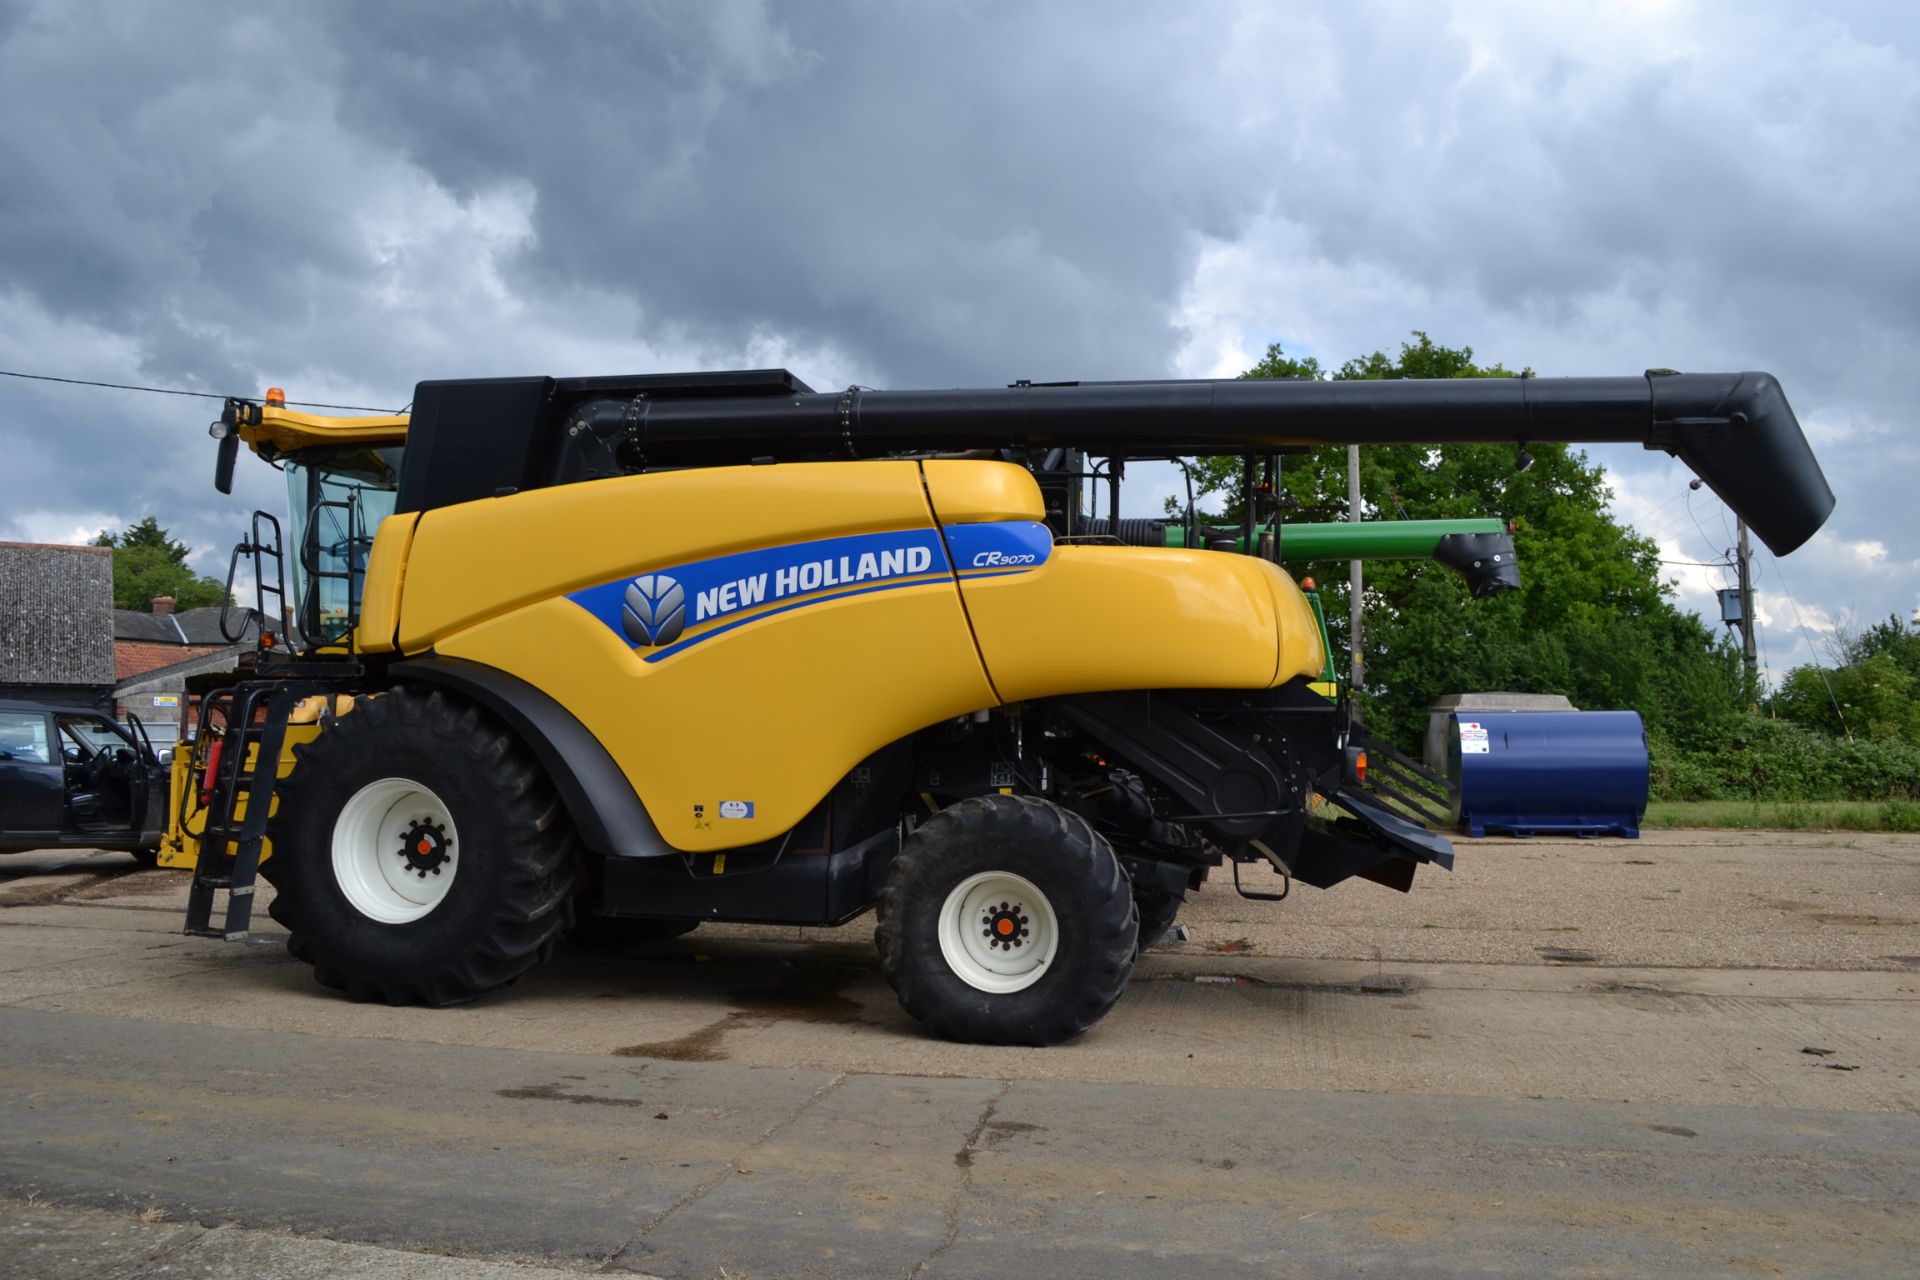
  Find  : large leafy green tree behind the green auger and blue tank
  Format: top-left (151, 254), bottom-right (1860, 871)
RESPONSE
top-left (1167, 332), bottom-right (1753, 745)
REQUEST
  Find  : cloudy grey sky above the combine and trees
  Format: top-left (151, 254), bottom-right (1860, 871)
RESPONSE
top-left (0, 0), bottom-right (1920, 676)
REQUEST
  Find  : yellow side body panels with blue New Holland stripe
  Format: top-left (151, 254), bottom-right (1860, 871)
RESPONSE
top-left (372, 461), bottom-right (1321, 852)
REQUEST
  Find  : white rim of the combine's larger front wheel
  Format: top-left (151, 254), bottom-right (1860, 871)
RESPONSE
top-left (334, 777), bottom-right (465, 925)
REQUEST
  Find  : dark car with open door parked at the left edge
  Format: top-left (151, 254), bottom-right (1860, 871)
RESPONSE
top-left (0, 699), bottom-right (167, 865)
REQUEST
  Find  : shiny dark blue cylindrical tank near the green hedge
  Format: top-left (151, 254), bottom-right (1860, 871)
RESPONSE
top-left (1446, 712), bottom-right (1647, 839)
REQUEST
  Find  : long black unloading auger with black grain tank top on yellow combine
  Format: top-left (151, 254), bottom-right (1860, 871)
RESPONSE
top-left (389, 370), bottom-right (1834, 555)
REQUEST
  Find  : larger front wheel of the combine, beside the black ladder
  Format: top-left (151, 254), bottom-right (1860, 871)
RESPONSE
top-left (261, 687), bottom-right (574, 1006)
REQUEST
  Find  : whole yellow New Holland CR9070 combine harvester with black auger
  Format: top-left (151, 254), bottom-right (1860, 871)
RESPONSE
top-left (173, 370), bottom-right (1834, 1044)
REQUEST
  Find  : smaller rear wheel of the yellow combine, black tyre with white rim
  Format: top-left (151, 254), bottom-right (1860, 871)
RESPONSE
top-left (874, 796), bottom-right (1137, 1046)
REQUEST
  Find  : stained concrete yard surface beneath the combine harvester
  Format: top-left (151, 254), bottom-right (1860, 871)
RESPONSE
top-left (0, 831), bottom-right (1920, 1280)
